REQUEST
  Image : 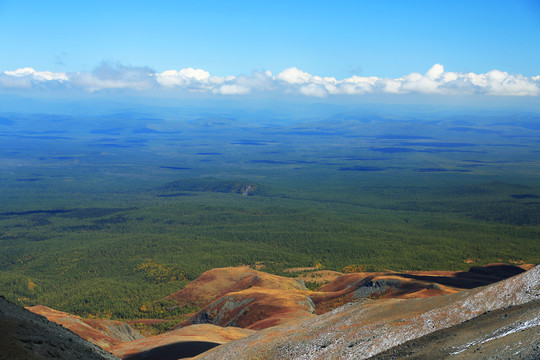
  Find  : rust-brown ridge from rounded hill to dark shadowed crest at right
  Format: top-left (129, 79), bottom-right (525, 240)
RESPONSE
top-left (168, 264), bottom-right (525, 330)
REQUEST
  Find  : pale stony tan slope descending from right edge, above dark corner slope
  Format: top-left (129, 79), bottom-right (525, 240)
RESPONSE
top-left (192, 266), bottom-right (540, 360)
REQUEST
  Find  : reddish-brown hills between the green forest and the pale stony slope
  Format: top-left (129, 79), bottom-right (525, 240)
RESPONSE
top-left (10, 264), bottom-right (530, 359)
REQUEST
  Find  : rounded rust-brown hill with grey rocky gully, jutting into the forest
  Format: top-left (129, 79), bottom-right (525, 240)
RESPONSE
top-left (165, 266), bottom-right (315, 330)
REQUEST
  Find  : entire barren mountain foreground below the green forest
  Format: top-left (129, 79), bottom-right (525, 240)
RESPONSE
top-left (7, 264), bottom-right (540, 360)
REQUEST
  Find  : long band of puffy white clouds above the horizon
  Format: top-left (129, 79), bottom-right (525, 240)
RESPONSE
top-left (0, 63), bottom-right (540, 97)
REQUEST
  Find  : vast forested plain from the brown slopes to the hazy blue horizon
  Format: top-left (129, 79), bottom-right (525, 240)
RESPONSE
top-left (0, 109), bottom-right (540, 327)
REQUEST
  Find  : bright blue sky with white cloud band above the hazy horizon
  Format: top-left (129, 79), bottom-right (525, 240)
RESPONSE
top-left (0, 0), bottom-right (540, 102)
